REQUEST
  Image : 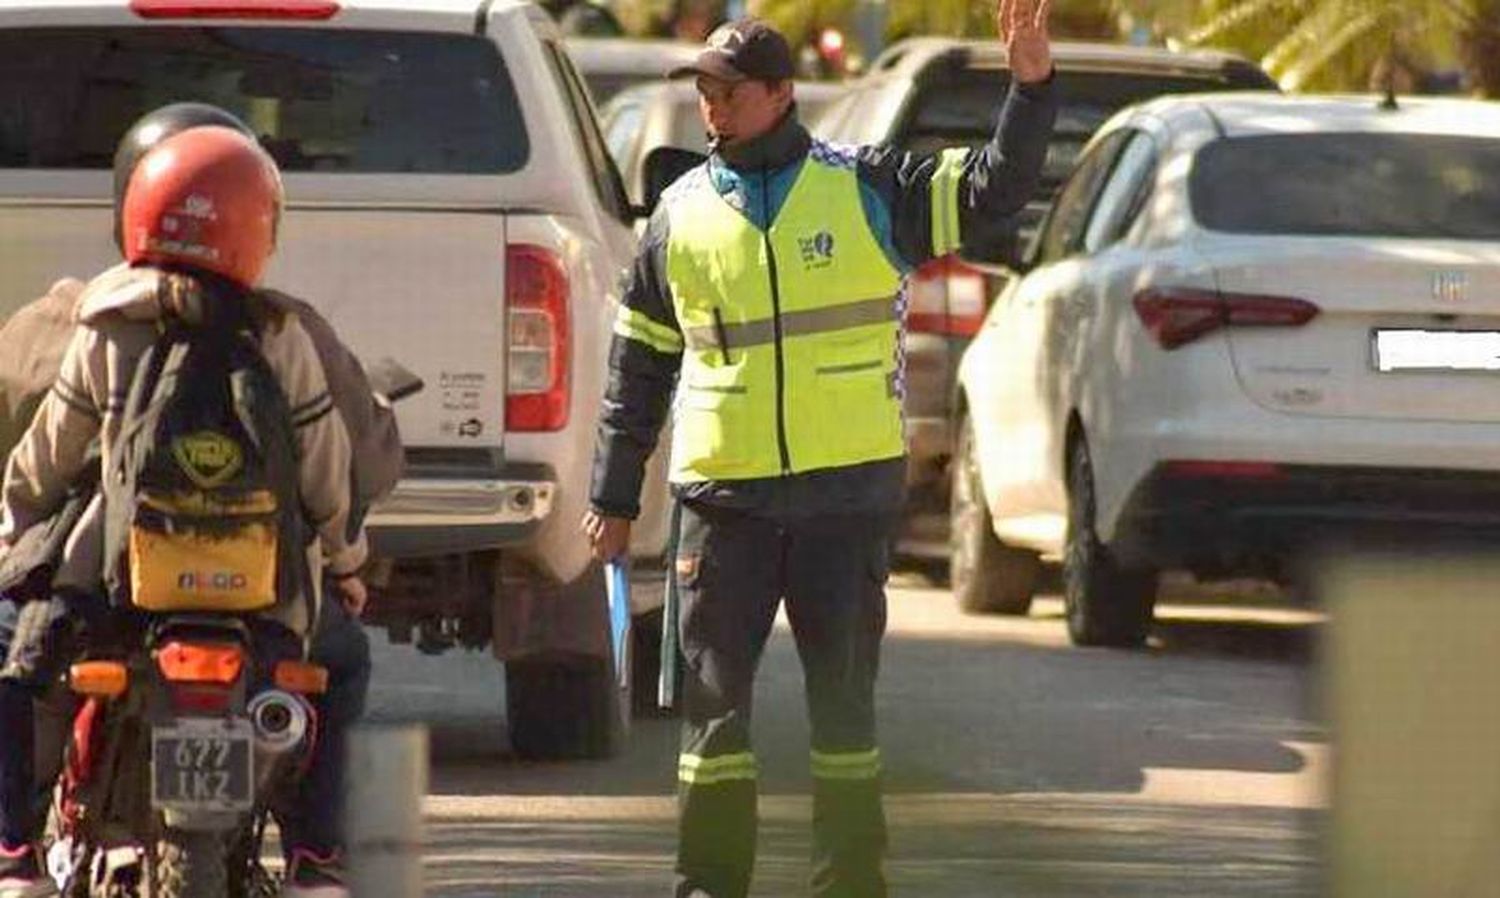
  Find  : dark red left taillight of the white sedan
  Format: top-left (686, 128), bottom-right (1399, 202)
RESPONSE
top-left (1134, 286), bottom-right (1320, 349)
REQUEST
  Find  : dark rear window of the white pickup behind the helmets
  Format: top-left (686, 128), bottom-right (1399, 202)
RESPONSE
top-left (0, 27), bottom-right (530, 174)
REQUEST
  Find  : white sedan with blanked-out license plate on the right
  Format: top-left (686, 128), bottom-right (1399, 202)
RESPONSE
top-left (953, 94), bottom-right (1500, 646)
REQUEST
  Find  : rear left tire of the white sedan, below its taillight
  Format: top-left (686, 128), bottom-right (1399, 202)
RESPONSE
top-left (1062, 439), bottom-right (1157, 648)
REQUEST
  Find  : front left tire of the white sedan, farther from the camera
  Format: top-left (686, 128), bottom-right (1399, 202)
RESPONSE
top-left (948, 417), bottom-right (1041, 615)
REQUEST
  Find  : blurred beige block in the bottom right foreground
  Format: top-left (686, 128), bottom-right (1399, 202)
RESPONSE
top-left (1320, 551), bottom-right (1500, 898)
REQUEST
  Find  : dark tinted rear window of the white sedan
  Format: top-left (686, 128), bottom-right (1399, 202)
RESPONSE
top-left (1190, 133), bottom-right (1500, 240)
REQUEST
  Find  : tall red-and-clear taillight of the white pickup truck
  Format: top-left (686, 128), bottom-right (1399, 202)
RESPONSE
top-left (506, 244), bottom-right (570, 433)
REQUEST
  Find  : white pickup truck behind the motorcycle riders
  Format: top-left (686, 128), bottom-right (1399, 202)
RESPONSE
top-left (0, 0), bottom-right (668, 757)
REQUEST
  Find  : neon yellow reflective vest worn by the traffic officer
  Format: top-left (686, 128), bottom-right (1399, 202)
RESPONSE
top-left (666, 156), bottom-right (905, 483)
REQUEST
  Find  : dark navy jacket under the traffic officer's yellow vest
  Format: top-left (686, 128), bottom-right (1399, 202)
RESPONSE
top-left (591, 81), bottom-right (1056, 519)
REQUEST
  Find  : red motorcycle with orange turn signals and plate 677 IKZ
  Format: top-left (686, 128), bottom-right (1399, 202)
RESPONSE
top-left (48, 613), bottom-right (327, 898)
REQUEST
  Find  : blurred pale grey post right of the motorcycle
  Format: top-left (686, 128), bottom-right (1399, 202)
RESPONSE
top-left (344, 724), bottom-right (428, 898)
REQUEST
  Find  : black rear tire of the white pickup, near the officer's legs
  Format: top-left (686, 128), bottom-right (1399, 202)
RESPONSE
top-left (506, 655), bottom-right (630, 760)
